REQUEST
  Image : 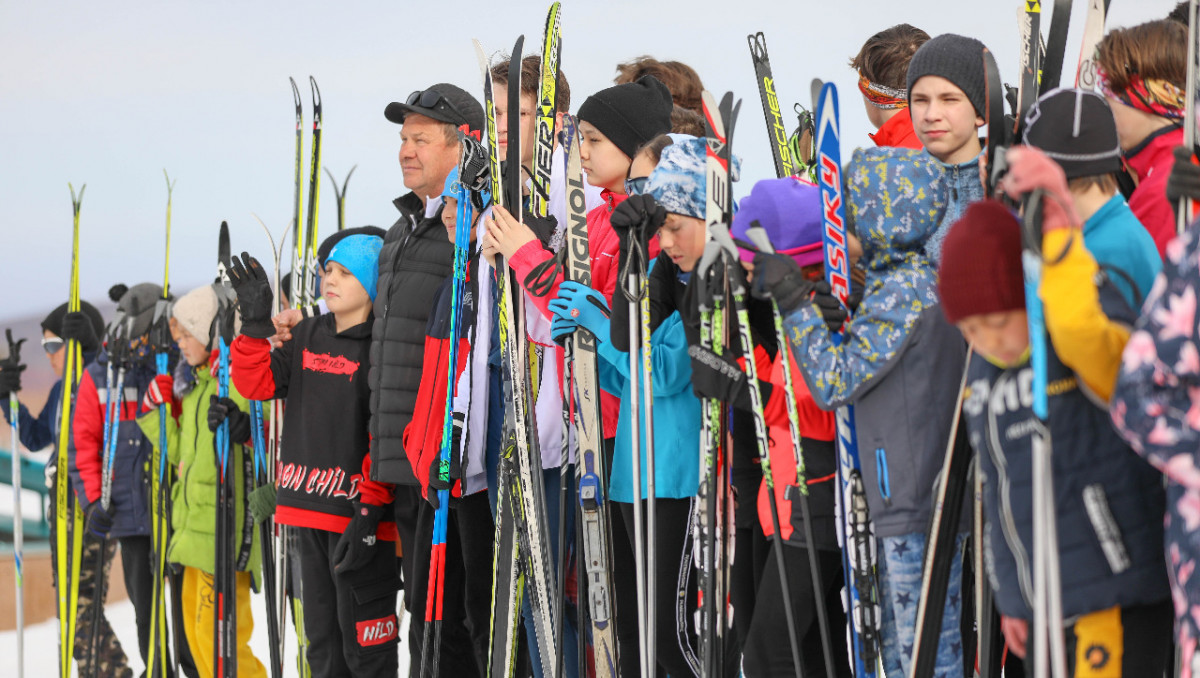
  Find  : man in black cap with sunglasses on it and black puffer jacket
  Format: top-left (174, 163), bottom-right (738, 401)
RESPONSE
top-left (370, 83), bottom-right (484, 676)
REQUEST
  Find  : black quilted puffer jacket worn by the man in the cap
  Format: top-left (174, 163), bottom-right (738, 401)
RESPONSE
top-left (370, 193), bottom-right (454, 485)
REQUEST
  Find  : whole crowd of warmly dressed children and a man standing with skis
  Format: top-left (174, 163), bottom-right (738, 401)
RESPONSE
top-left (7, 6), bottom-right (1200, 677)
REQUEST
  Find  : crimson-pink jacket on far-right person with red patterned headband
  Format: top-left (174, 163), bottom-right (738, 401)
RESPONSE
top-left (1126, 127), bottom-right (1183, 257)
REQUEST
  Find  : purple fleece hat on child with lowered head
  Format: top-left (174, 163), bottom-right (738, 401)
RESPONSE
top-left (732, 176), bottom-right (824, 266)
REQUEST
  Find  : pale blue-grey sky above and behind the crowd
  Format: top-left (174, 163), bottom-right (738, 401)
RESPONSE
top-left (0, 0), bottom-right (1175, 318)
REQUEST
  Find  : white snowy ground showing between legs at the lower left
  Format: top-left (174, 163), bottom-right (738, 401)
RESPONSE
top-left (0, 596), bottom-right (408, 678)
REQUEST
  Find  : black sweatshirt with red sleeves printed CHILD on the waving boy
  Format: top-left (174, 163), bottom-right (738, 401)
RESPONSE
top-left (230, 313), bottom-right (396, 541)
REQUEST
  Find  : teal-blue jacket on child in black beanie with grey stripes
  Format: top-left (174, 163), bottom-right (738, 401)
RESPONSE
top-left (1084, 193), bottom-right (1163, 310)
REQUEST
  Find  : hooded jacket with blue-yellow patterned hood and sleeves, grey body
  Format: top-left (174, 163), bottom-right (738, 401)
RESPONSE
top-left (785, 149), bottom-right (966, 538)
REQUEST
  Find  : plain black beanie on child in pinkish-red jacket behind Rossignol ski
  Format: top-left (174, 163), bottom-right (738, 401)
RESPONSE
top-left (578, 76), bottom-right (673, 160)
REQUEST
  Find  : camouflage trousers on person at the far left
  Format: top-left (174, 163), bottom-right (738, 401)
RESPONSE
top-left (50, 502), bottom-right (133, 678)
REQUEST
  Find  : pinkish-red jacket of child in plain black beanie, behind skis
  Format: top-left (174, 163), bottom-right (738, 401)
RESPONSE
top-left (509, 190), bottom-right (633, 438)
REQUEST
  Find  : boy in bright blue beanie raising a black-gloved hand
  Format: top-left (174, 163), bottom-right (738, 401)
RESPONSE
top-left (226, 234), bottom-right (400, 676)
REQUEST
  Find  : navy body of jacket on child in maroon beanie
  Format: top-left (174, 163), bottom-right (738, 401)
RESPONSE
top-left (962, 286), bottom-right (1170, 619)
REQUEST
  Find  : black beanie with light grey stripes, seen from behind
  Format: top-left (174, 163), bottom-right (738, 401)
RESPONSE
top-left (1025, 89), bottom-right (1121, 179)
